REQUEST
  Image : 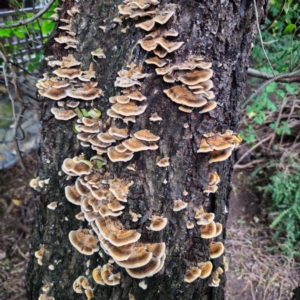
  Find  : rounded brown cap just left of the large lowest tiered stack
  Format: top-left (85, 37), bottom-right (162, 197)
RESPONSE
top-left (69, 229), bottom-right (99, 255)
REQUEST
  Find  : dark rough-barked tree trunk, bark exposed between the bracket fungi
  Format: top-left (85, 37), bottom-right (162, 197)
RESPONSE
top-left (27, 0), bottom-right (268, 300)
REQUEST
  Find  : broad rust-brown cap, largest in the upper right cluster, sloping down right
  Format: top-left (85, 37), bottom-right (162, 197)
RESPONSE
top-left (164, 85), bottom-right (207, 107)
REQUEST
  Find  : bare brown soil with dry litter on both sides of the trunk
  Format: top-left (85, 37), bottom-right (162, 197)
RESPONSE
top-left (0, 152), bottom-right (300, 300)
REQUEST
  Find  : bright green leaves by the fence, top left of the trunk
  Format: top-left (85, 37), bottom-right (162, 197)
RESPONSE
top-left (0, 0), bottom-right (58, 72)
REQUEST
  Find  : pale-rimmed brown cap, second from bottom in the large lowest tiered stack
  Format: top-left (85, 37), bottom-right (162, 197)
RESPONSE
top-left (116, 246), bottom-right (152, 269)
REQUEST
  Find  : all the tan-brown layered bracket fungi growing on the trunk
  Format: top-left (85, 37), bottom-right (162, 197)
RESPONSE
top-left (31, 0), bottom-right (241, 299)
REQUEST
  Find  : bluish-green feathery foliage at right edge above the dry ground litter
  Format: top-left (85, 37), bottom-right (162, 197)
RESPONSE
top-left (261, 162), bottom-right (300, 256)
